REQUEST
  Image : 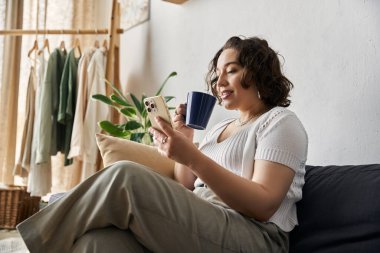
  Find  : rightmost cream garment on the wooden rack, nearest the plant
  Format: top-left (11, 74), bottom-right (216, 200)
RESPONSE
top-left (71, 47), bottom-right (109, 180)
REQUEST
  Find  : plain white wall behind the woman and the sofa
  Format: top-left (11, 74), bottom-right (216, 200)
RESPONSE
top-left (113, 0), bottom-right (380, 165)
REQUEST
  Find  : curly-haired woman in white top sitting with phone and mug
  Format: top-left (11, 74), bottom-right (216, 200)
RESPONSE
top-left (18, 37), bottom-right (307, 253)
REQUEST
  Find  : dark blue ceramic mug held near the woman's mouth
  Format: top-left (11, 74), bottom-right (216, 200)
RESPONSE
top-left (186, 91), bottom-right (216, 130)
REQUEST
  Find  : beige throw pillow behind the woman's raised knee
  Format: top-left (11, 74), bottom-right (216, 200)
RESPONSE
top-left (96, 134), bottom-right (174, 178)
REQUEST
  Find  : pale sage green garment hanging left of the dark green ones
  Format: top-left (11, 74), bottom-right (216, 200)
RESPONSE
top-left (36, 48), bottom-right (66, 164)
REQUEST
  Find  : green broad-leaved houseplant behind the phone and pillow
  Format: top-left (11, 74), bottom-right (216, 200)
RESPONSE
top-left (92, 71), bottom-right (177, 144)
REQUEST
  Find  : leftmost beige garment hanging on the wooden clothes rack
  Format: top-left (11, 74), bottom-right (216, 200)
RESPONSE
top-left (13, 65), bottom-right (36, 177)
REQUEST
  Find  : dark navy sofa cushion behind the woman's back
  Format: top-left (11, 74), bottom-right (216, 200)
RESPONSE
top-left (290, 164), bottom-right (380, 253)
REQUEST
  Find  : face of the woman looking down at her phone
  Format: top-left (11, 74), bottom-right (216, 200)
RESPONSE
top-left (216, 48), bottom-right (258, 111)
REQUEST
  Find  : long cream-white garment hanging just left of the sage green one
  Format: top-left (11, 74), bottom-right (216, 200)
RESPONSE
top-left (27, 53), bottom-right (51, 196)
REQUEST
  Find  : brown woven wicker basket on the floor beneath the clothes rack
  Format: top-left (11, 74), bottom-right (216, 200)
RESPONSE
top-left (0, 185), bottom-right (41, 229)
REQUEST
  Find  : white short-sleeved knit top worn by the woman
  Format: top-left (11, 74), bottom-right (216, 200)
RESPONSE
top-left (194, 107), bottom-right (308, 232)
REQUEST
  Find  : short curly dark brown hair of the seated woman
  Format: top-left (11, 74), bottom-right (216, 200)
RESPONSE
top-left (206, 36), bottom-right (293, 107)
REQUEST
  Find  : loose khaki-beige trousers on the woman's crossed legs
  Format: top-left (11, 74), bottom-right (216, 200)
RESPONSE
top-left (17, 161), bottom-right (288, 253)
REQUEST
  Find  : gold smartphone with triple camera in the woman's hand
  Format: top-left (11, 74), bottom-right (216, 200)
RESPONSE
top-left (144, 96), bottom-right (172, 129)
